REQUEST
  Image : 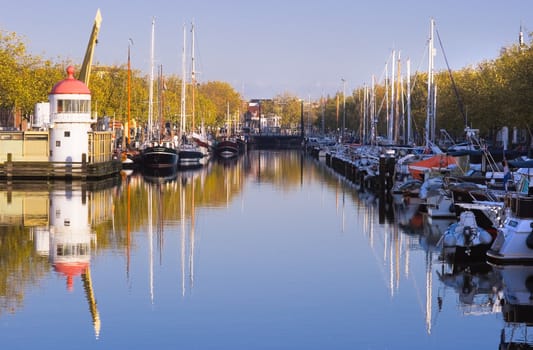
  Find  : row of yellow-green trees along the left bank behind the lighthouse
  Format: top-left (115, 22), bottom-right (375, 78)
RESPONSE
top-left (0, 30), bottom-right (244, 130)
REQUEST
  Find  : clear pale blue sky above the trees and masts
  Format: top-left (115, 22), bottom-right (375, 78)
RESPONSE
top-left (0, 0), bottom-right (533, 99)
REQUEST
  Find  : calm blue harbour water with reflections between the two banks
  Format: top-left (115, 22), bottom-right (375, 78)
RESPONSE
top-left (0, 151), bottom-right (525, 349)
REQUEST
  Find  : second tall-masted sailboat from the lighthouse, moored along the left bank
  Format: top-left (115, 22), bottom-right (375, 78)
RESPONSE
top-left (179, 22), bottom-right (204, 167)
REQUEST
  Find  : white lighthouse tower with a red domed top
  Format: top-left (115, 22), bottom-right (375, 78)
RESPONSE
top-left (48, 66), bottom-right (94, 163)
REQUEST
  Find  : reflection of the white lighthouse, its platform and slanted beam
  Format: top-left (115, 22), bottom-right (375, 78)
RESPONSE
top-left (10, 184), bottom-right (113, 338)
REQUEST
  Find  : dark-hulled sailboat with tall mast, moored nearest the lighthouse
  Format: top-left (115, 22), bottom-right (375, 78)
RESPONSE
top-left (141, 19), bottom-right (178, 175)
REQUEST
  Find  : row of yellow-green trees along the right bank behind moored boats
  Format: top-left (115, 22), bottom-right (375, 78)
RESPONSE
top-left (314, 35), bottom-right (533, 144)
